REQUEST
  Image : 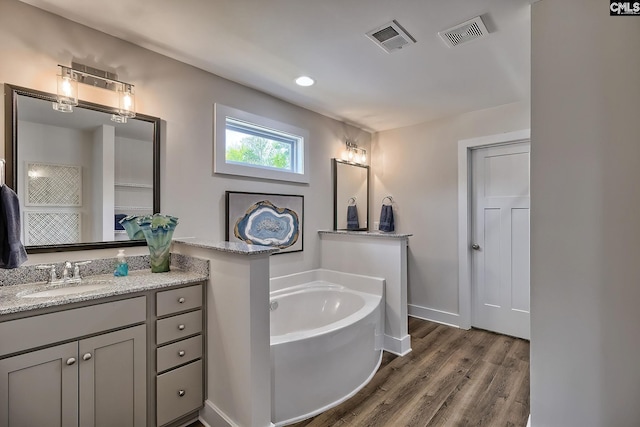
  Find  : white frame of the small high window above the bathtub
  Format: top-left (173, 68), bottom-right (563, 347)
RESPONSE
top-left (213, 103), bottom-right (309, 184)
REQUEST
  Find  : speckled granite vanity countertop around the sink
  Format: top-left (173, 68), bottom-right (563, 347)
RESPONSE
top-left (0, 266), bottom-right (208, 316)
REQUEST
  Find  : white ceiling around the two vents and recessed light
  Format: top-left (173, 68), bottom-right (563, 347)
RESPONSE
top-left (17, 0), bottom-right (532, 131)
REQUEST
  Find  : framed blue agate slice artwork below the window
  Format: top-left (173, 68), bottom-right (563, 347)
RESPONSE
top-left (225, 191), bottom-right (304, 255)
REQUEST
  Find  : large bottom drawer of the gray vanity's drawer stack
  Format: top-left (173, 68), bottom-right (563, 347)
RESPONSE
top-left (156, 360), bottom-right (203, 426)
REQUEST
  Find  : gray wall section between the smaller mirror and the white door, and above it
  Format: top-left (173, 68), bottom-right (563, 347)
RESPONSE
top-left (371, 101), bottom-right (530, 324)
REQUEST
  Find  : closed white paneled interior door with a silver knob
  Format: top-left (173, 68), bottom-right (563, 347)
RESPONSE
top-left (470, 142), bottom-right (530, 339)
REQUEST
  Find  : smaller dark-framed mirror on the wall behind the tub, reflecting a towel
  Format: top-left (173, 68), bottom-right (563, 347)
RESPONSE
top-left (333, 159), bottom-right (369, 231)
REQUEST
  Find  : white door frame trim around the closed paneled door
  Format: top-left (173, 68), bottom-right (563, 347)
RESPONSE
top-left (458, 129), bottom-right (531, 329)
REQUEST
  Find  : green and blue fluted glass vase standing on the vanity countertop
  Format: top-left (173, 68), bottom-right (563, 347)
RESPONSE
top-left (135, 214), bottom-right (178, 273)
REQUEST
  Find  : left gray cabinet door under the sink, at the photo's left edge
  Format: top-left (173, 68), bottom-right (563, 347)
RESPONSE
top-left (0, 342), bottom-right (78, 427)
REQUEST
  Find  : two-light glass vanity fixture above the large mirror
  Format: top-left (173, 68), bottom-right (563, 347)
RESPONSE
top-left (53, 62), bottom-right (136, 123)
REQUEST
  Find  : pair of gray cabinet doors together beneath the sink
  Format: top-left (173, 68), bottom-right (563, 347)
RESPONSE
top-left (0, 325), bottom-right (146, 427)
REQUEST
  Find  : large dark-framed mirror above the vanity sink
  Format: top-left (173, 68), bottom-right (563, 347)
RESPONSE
top-left (4, 84), bottom-right (160, 253)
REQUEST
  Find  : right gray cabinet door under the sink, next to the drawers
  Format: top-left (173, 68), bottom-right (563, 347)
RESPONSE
top-left (79, 325), bottom-right (147, 427)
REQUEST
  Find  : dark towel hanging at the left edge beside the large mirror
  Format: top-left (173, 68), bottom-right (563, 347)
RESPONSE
top-left (0, 185), bottom-right (27, 268)
